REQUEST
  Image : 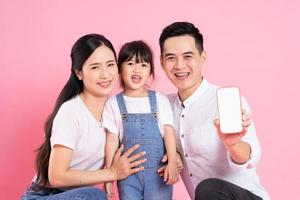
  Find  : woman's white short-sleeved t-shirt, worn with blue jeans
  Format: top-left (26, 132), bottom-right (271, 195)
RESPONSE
top-left (50, 95), bottom-right (106, 171)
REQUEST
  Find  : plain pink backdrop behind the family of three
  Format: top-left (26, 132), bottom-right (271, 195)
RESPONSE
top-left (0, 0), bottom-right (300, 200)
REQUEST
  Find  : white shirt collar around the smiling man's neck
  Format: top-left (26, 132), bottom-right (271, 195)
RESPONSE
top-left (176, 78), bottom-right (209, 108)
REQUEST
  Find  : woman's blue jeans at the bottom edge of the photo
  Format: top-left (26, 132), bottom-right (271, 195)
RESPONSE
top-left (21, 183), bottom-right (107, 200)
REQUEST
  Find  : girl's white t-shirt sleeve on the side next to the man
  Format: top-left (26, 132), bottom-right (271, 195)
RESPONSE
top-left (157, 93), bottom-right (174, 127)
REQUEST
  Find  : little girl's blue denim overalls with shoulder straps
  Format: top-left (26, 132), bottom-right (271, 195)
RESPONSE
top-left (117, 90), bottom-right (173, 200)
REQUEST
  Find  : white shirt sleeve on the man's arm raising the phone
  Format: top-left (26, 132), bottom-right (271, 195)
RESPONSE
top-left (227, 97), bottom-right (261, 169)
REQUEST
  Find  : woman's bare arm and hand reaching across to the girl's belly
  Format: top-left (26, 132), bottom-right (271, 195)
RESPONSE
top-left (48, 145), bottom-right (146, 187)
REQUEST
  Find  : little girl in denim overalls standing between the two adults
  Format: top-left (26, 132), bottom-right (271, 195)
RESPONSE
top-left (103, 41), bottom-right (178, 200)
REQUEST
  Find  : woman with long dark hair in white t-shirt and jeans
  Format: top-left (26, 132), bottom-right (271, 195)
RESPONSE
top-left (21, 34), bottom-right (145, 200)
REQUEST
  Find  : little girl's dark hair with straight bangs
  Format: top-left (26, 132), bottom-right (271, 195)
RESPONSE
top-left (118, 40), bottom-right (155, 88)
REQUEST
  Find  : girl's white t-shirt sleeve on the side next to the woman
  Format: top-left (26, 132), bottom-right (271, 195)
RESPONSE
top-left (102, 97), bottom-right (119, 135)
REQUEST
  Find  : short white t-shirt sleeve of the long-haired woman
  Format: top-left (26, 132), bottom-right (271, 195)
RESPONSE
top-left (50, 104), bottom-right (80, 150)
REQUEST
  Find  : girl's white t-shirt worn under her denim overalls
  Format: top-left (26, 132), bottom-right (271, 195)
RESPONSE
top-left (102, 92), bottom-right (174, 140)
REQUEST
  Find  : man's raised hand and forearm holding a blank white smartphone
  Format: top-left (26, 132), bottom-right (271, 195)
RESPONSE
top-left (214, 87), bottom-right (251, 164)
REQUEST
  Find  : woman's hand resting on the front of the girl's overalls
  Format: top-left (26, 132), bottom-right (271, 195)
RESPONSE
top-left (110, 144), bottom-right (147, 180)
